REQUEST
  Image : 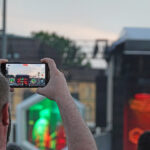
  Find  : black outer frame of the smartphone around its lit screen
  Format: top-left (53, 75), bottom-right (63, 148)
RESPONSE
top-left (1, 62), bottom-right (49, 88)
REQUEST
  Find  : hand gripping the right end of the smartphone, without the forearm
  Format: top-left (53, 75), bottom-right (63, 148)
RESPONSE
top-left (37, 58), bottom-right (70, 102)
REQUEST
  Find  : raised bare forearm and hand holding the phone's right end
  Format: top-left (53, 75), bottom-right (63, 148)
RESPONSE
top-left (37, 58), bottom-right (97, 150)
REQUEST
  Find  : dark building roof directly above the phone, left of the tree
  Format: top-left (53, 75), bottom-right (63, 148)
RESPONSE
top-left (0, 35), bottom-right (61, 65)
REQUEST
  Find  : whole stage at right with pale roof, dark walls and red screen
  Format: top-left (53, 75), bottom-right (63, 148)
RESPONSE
top-left (96, 28), bottom-right (150, 150)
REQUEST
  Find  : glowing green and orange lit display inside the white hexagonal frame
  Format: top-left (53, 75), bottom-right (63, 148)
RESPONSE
top-left (27, 98), bottom-right (65, 150)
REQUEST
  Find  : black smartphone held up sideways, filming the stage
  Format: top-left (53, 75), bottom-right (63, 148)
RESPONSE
top-left (1, 62), bottom-right (49, 88)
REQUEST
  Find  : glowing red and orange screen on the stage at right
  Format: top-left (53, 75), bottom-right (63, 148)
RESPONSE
top-left (124, 93), bottom-right (150, 150)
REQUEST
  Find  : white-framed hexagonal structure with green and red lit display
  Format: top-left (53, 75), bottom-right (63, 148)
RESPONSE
top-left (16, 94), bottom-right (85, 150)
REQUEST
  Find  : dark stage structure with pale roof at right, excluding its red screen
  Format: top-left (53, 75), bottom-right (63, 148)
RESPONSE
top-left (97, 28), bottom-right (150, 150)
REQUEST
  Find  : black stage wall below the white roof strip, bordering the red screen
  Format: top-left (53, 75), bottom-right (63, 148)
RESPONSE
top-left (112, 56), bottom-right (150, 150)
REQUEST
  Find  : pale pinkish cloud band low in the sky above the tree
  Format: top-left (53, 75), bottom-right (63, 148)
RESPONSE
top-left (8, 17), bottom-right (117, 41)
